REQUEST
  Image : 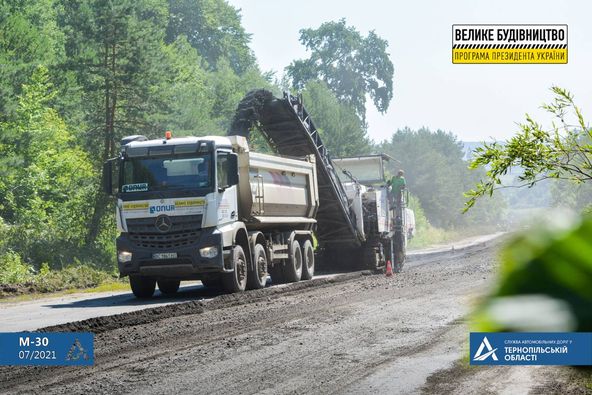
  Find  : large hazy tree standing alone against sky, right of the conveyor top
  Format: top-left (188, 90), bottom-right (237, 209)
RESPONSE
top-left (286, 19), bottom-right (394, 121)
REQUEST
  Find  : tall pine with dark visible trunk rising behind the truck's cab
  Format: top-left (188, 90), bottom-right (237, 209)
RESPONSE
top-left (59, 0), bottom-right (168, 243)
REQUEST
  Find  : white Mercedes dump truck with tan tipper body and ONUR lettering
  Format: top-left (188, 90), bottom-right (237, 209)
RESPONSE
top-left (104, 133), bottom-right (319, 297)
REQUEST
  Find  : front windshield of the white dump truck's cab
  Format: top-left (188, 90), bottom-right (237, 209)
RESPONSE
top-left (120, 155), bottom-right (212, 193)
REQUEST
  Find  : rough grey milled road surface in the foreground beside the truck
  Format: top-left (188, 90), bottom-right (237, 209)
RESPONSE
top-left (0, 238), bottom-right (572, 394)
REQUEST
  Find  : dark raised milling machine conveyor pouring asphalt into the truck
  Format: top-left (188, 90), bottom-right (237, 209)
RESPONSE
top-left (228, 89), bottom-right (363, 246)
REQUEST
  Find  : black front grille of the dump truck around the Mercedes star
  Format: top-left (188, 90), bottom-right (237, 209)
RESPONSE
top-left (127, 215), bottom-right (202, 250)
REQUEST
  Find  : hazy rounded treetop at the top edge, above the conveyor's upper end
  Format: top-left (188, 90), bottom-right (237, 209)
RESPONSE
top-left (166, 0), bottom-right (255, 74)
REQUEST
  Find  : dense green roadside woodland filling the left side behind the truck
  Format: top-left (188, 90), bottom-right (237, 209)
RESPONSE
top-left (0, 0), bottom-right (270, 277)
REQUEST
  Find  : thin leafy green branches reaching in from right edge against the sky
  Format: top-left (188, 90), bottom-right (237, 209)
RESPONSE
top-left (465, 87), bottom-right (592, 210)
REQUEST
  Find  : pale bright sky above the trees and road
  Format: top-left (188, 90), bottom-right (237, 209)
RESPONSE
top-left (229, 0), bottom-right (592, 141)
